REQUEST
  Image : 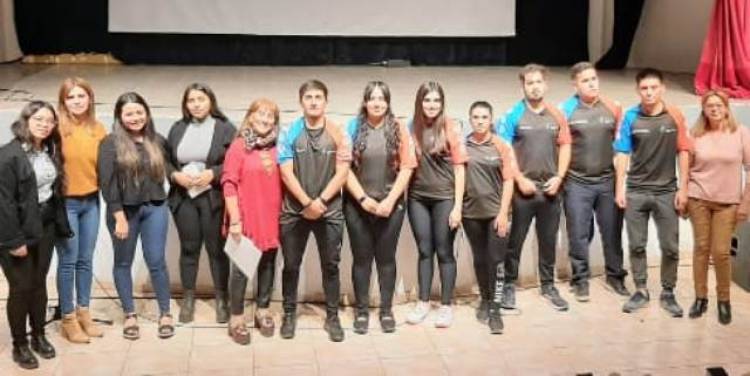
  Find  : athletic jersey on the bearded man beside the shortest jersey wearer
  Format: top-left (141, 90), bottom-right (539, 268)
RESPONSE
top-left (497, 100), bottom-right (571, 186)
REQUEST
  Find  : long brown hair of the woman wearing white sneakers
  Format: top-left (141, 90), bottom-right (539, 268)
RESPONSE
top-left (412, 81), bottom-right (448, 155)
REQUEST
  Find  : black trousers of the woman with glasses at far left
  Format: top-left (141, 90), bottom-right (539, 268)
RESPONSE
top-left (0, 220), bottom-right (55, 346)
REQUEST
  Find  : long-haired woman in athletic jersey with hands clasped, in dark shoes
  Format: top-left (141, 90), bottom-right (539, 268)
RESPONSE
top-left (344, 81), bottom-right (416, 334)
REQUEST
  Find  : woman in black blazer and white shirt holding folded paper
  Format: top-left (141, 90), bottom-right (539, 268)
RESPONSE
top-left (167, 83), bottom-right (237, 323)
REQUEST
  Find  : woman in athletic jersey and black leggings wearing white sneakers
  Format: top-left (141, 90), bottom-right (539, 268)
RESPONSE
top-left (407, 81), bottom-right (468, 328)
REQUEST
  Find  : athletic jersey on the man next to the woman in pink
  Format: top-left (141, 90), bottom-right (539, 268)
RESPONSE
top-left (613, 105), bottom-right (691, 193)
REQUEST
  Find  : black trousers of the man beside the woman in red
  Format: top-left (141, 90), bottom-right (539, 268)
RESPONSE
top-left (281, 218), bottom-right (344, 317)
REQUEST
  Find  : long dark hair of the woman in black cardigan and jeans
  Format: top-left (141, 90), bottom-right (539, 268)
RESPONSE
top-left (112, 92), bottom-right (164, 184)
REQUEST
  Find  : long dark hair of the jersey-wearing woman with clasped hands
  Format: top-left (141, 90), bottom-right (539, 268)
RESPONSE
top-left (352, 81), bottom-right (401, 170)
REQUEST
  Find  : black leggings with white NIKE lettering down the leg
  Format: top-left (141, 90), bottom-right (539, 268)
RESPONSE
top-left (463, 218), bottom-right (508, 303)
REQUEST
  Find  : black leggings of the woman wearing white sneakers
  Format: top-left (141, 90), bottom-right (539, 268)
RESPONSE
top-left (409, 198), bottom-right (456, 305)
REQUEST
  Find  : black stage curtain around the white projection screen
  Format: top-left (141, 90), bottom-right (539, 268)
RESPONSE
top-left (14, 0), bottom-right (588, 65)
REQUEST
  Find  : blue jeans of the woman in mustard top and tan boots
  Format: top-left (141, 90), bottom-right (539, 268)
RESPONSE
top-left (56, 194), bottom-right (99, 314)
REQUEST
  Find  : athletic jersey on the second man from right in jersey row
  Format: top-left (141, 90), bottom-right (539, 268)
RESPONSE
top-left (560, 95), bottom-right (622, 184)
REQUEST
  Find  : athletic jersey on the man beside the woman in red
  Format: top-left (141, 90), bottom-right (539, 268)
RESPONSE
top-left (278, 117), bottom-right (351, 223)
